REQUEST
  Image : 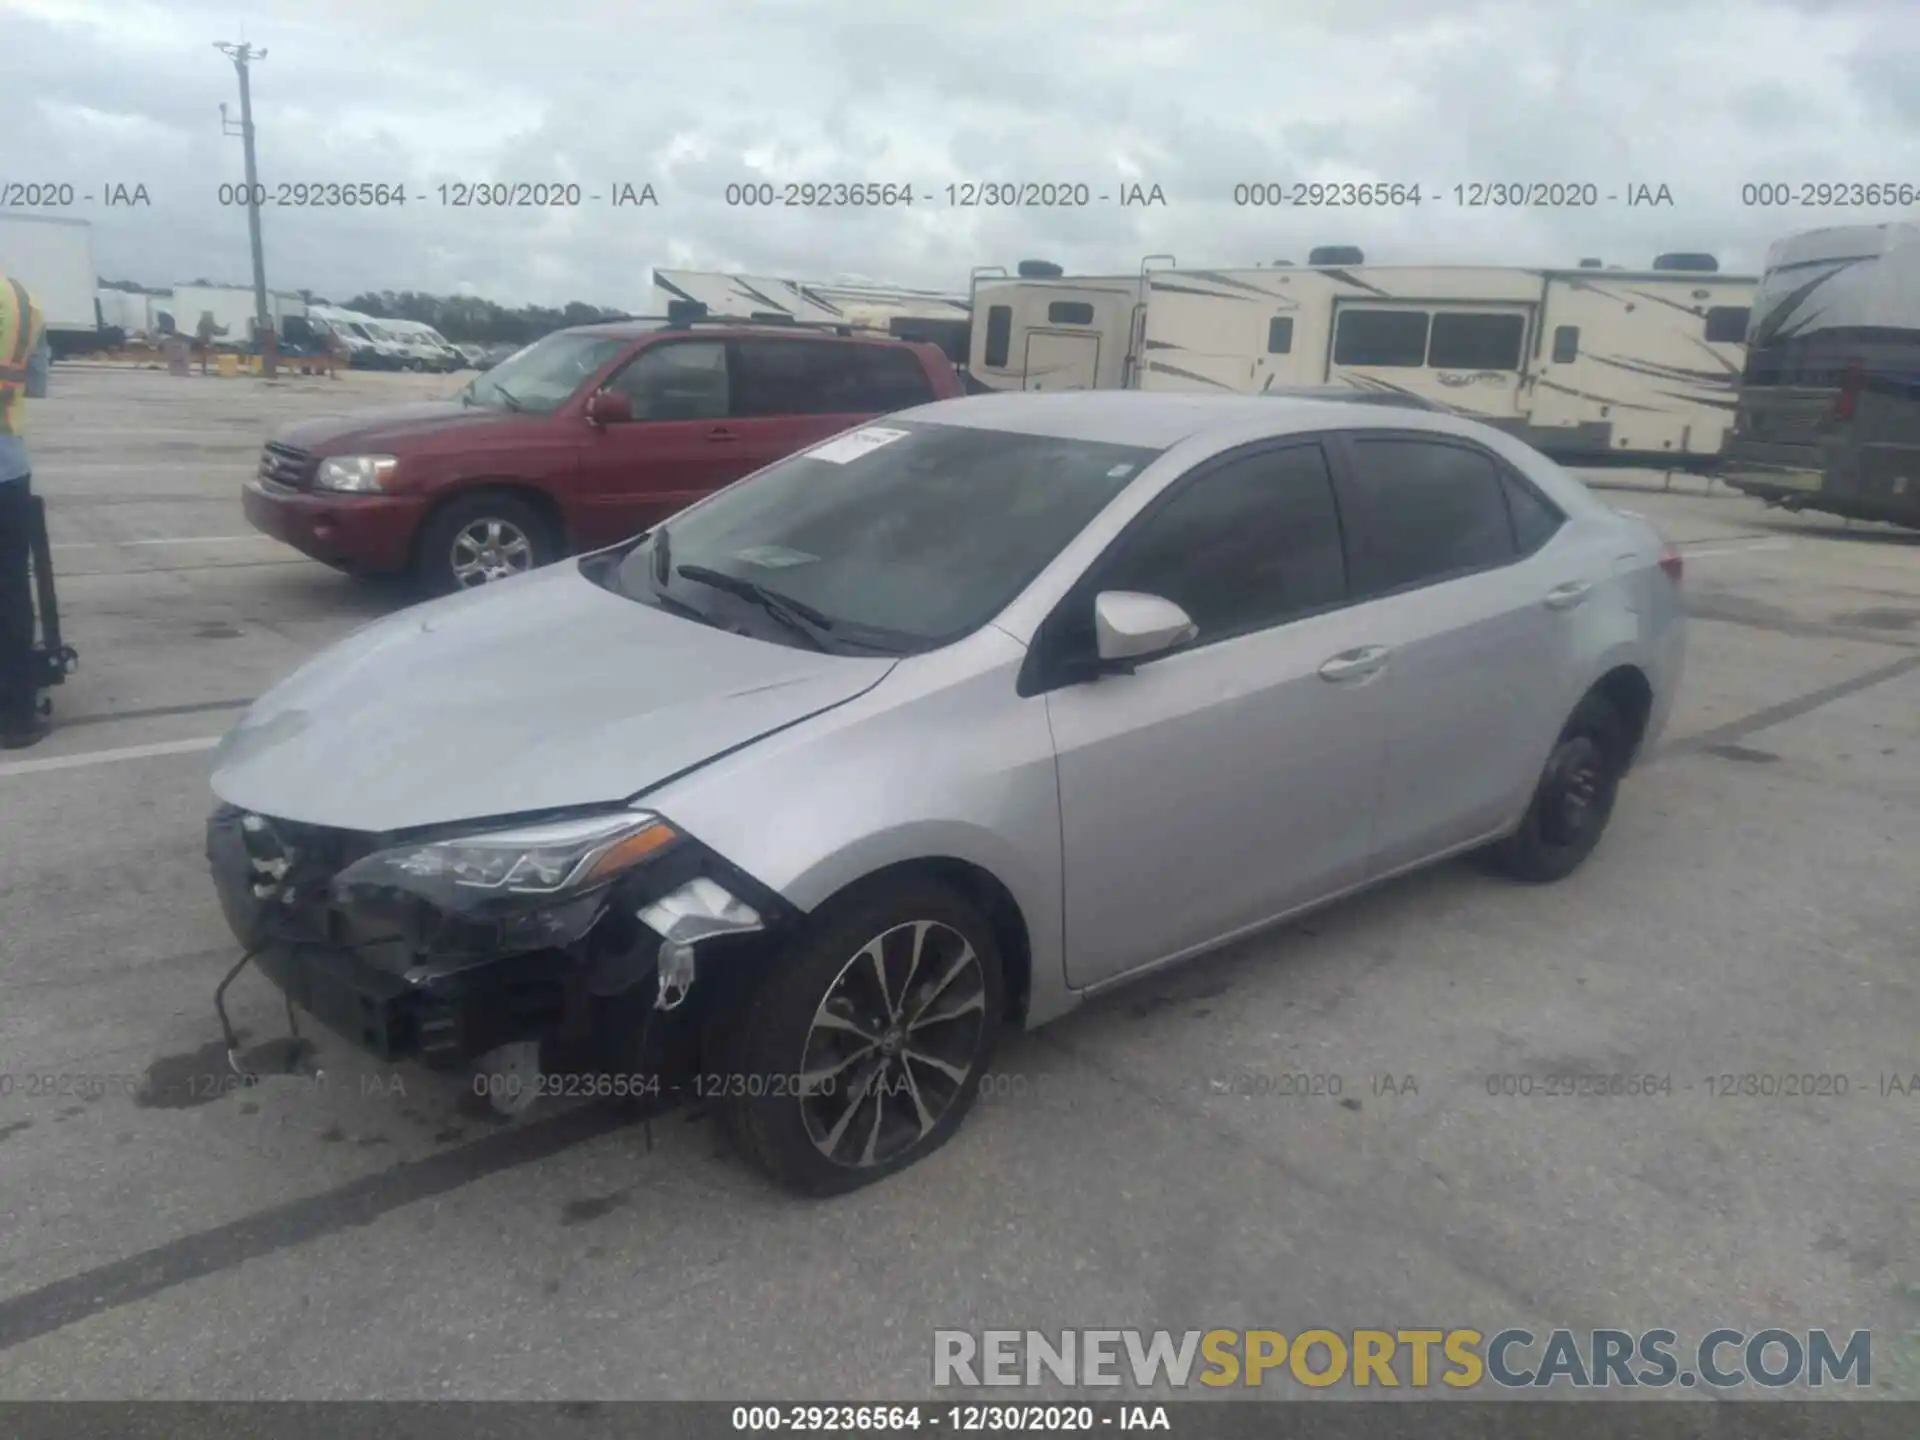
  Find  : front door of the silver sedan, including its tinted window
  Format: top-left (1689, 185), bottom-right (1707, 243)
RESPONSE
top-left (1035, 442), bottom-right (1384, 987)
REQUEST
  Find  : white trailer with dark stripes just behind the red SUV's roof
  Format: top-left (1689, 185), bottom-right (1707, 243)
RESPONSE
top-left (653, 269), bottom-right (968, 363)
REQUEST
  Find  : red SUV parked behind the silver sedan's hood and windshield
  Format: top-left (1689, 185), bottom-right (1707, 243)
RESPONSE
top-left (244, 321), bottom-right (962, 591)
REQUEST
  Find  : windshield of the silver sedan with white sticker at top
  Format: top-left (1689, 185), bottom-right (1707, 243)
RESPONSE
top-left (609, 420), bottom-right (1160, 653)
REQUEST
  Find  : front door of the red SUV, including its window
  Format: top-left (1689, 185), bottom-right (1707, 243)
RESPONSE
top-left (574, 338), bottom-right (741, 549)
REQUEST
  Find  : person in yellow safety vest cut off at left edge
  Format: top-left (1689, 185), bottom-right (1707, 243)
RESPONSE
top-left (0, 273), bottom-right (52, 751)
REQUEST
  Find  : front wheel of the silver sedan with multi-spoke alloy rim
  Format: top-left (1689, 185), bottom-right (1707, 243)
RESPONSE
top-left (720, 879), bottom-right (1004, 1196)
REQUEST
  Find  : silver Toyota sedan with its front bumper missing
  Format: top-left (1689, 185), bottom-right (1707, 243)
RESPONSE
top-left (207, 394), bottom-right (1682, 1194)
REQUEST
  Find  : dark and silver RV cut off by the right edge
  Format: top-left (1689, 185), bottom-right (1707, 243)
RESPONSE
top-left (1724, 221), bottom-right (1920, 530)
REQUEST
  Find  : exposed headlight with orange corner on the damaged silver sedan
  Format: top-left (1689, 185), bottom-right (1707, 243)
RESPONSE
top-left (332, 810), bottom-right (680, 948)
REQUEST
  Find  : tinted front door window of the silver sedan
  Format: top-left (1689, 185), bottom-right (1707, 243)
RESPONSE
top-left (1098, 445), bottom-right (1346, 641)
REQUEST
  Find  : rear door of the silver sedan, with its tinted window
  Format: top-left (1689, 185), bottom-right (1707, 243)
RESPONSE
top-left (1334, 430), bottom-right (1582, 876)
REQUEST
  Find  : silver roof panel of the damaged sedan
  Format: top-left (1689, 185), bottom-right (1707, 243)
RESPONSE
top-left (900, 390), bottom-right (1480, 449)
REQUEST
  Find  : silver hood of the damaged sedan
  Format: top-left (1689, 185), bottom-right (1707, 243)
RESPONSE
top-left (213, 563), bottom-right (895, 833)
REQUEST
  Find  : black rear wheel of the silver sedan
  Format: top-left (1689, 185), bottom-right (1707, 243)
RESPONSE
top-left (1486, 693), bottom-right (1628, 885)
